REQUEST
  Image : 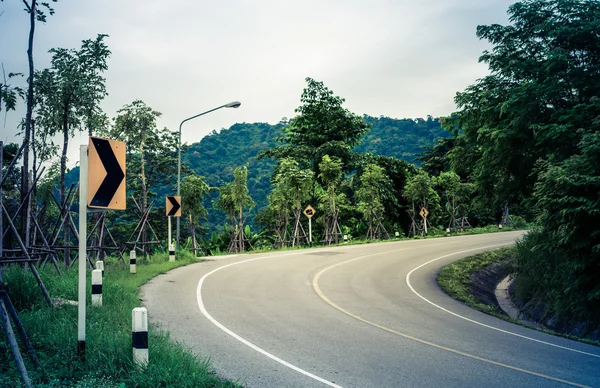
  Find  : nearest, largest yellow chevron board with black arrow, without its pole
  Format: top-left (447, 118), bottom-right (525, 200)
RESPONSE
top-left (88, 137), bottom-right (127, 210)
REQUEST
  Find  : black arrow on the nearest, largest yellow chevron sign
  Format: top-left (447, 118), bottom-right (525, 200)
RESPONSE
top-left (90, 139), bottom-right (125, 207)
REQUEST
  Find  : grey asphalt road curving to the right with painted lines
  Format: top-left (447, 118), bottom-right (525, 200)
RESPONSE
top-left (142, 232), bottom-right (600, 388)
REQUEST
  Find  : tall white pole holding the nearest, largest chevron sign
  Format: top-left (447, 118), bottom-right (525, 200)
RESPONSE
top-left (77, 145), bottom-right (88, 358)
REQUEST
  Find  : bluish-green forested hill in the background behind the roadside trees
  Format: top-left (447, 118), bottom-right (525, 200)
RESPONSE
top-left (183, 115), bottom-right (447, 229)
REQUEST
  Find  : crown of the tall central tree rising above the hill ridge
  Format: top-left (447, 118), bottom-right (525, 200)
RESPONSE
top-left (262, 78), bottom-right (369, 176)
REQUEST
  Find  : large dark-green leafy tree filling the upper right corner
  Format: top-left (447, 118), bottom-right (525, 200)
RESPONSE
top-left (450, 0), bottom-right (600, 218)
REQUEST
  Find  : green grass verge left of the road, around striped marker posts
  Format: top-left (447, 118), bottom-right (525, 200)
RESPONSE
top-left (0, 252), bottom-right (238, 387)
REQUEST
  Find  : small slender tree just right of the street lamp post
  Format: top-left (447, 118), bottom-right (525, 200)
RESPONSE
top-left (179, 174), bottom-right (210, 253)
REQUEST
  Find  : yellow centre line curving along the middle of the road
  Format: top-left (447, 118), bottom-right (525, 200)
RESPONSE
top-left (313, 249), bottom-right (590, 388)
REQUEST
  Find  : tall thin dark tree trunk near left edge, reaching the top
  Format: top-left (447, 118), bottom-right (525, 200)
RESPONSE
top-left (21, 0), bottom-right (37, 247)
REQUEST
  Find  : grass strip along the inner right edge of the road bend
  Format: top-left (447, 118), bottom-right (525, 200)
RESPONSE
top-left (437, 247), bottom-right (600, 346)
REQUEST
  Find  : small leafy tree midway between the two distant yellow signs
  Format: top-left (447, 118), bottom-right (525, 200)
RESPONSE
top-left (356, 164), bottom-right (389, 240)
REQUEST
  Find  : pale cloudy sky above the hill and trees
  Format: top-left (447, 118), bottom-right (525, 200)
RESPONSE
top-left (0, 0), bottom-right (514, 165)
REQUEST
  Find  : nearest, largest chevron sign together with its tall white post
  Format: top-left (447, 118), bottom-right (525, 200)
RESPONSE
top-left (77, 137), bottom-right (127, 358)
